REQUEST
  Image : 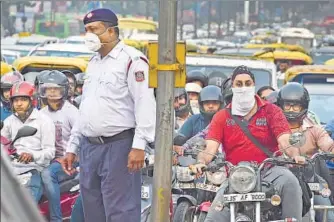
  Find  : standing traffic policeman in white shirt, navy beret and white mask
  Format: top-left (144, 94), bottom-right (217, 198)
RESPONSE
top-left (63, 8), bottom-right (156, 222)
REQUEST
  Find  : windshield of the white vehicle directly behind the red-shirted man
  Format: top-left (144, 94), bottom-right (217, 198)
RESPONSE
top-left (187, 65), bottom-right (272, 90)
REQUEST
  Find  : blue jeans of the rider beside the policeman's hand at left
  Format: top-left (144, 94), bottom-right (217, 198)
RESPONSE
top-left (41, 161), bottom-right (76, 222)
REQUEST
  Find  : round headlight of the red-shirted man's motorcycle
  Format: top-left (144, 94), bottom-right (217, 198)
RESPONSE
top-left (229, 166), bottom-right (256, 193)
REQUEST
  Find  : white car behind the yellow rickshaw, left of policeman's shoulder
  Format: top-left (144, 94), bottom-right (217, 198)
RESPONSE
top-left (28, 43), bottom-right (95, 58)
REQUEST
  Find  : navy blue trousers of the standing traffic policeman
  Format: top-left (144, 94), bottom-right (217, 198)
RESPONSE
top-left (80, 137), bottom-right (141, 222)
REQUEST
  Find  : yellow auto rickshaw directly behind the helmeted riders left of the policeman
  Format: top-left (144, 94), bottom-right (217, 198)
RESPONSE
top-left (13, 56), bottom-right (88, 83)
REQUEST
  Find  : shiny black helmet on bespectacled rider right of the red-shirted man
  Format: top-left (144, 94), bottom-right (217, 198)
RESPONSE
top-left (277, 82), bottom-right (310, 121)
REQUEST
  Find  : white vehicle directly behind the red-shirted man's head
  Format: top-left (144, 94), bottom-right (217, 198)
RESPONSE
top-left (186, 55), bottom-right (277, 90)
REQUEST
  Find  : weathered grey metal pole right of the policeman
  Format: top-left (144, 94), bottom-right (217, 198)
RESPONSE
top-left (151, 0), bottom-right (177, 222)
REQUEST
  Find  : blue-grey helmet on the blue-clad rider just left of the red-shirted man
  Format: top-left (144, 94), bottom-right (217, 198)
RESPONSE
top-left (198, 85), bottom-right (224, 118)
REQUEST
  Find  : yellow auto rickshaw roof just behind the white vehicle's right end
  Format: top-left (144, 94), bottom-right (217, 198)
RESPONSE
top-left (253, 49), bottom-right (313, 66)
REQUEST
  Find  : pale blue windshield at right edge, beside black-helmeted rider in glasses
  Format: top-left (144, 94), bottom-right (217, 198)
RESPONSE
top-left (309, 94), bottom-right (334, 125)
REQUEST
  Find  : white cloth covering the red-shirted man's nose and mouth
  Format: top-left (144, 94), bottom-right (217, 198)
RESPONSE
top-left (232, 86), bottom-right (256, 116)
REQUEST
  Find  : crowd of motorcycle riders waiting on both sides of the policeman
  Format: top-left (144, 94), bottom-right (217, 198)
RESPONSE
top-left (1, 63), bottom-right (334, 221)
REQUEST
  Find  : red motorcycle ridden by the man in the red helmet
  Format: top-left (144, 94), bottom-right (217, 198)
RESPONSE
top-left (1, 126), bottom-right (79, 221)
